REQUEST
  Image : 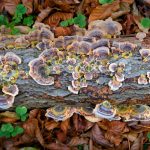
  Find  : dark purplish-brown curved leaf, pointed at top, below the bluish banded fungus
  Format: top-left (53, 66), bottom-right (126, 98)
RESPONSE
top-left (92, 124), bottom-right (112, 147)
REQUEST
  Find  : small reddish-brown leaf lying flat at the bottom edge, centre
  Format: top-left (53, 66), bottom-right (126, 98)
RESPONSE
top-left (67, 137), bottom-right (89, 146)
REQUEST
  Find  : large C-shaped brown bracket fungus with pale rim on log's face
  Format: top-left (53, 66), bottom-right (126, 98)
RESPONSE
top-left (29, 58), bottom-right (54, 85)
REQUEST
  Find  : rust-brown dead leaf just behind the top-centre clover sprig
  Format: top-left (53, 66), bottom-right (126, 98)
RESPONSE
top-left (44, 12), bottom-right (73, 27)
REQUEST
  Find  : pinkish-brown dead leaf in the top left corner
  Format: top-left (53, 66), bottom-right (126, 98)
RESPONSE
top-left (0, 0), bottom-right (20, 15)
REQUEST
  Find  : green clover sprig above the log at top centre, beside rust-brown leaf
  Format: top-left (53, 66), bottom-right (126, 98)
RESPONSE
top-left (60, 13), bottom-right (87, 28)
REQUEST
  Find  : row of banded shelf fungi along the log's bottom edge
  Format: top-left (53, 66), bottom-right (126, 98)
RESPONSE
top-left (45, 101), bottom-right (150, 122)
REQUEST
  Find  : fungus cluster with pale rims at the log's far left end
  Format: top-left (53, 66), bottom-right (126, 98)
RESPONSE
top-left (0, 52), bottom-right (21, 109)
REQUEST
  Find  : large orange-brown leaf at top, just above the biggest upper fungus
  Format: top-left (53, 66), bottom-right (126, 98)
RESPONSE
top-left (88, 0), bottom-right (120, 22)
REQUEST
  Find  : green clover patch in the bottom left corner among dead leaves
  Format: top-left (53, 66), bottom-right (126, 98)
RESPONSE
top-left (0, 123), bottom-right (24, 138)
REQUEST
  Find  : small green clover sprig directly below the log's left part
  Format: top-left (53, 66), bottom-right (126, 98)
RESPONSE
top-left (16, 106), bottom-right (28, 121)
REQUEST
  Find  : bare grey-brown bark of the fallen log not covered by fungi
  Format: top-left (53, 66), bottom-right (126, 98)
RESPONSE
top-left (0, 37), bottom-right (150, 109)
